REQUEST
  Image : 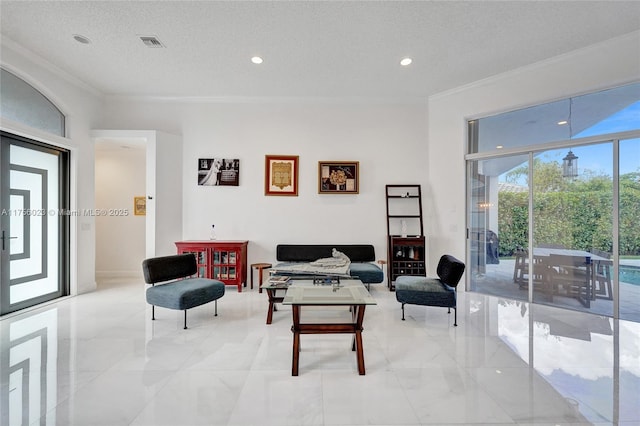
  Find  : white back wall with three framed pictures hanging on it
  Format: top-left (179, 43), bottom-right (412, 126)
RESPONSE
top-left (103, 99), bottom-right (430, 263)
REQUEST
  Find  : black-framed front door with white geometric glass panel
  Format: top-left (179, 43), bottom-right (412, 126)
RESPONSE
top-left (0, 133), bottom-right (69, 314)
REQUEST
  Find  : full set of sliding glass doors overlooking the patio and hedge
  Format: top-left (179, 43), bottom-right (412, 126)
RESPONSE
top-left (467, 138), bottom-right (640, 321)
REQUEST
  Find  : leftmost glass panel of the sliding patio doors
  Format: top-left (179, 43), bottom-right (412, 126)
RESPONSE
top-left (468, 155), bottom-right (529, 301)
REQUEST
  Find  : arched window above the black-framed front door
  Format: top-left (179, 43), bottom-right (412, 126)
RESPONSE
top-left (0, 69), bottom-right (65, 137)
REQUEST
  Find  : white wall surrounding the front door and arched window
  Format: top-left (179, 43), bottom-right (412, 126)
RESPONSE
top-left (0, 37), bottom-right (102, 294)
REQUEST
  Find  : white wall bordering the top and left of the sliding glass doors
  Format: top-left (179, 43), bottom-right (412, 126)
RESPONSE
top-left (425, 32), bottom-right (640, 276)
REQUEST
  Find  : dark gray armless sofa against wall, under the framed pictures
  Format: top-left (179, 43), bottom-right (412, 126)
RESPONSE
top-left (274, 244), bottom-right (384, 287)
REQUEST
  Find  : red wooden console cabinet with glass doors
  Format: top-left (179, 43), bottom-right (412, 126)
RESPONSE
top-left (176, 240), bottom-right (249, 293)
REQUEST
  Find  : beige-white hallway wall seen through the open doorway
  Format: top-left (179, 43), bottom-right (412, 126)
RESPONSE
top-left (95, 141), bottom-right (146, 278)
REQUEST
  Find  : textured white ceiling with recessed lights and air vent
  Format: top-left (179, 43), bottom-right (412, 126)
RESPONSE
top-left (0, 0), bottom-right (640, 98)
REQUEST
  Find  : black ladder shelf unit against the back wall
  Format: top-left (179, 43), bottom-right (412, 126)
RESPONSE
top-left (385, 185), bottom-right (427, 291)
